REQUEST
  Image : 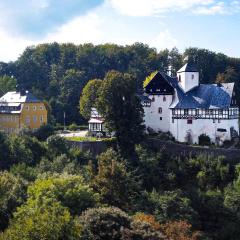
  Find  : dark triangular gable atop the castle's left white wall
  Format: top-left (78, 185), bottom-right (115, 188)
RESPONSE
top-left (145, 72), bottom-right (174, 95)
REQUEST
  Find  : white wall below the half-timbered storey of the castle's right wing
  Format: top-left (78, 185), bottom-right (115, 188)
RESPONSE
top-left (170, 116), bottom-right (239, 143)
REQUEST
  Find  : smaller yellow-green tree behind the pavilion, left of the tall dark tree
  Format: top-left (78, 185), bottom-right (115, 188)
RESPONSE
top-left (80, 79), bottom-right (102, 119)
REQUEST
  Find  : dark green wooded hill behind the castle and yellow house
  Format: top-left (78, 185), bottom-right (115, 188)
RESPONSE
top-left (0, 43), bottom-right (240, 124)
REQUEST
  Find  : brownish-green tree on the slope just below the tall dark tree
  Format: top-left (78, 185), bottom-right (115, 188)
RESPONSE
top-left (92, 149), bottom-right (140, 210)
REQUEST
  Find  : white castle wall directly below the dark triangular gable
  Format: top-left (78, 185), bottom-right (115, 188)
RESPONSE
top-left (144, 95), bottom-right (172, 132)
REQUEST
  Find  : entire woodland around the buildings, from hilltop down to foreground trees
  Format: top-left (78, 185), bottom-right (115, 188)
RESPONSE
top-left (0, 43), bottom-right (240, 240)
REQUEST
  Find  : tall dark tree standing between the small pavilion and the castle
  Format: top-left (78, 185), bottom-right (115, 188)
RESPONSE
top-left (97, 71), bottom-right (144, 156)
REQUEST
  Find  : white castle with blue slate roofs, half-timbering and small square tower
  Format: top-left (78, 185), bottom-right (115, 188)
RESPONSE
top-left (142, 63), bottom-right (239, 144)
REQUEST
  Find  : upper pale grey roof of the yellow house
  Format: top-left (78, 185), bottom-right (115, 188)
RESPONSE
top-left (0, 91), bottom-right (41, 103)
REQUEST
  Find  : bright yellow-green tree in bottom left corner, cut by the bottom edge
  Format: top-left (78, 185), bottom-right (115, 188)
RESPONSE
top-left (0, 201), bottom-right (81, 240)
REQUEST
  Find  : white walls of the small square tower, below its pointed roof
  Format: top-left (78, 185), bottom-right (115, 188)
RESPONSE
top-left (177, 72), bottom-right (199, 92)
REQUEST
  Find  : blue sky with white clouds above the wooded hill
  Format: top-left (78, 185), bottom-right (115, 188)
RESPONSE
top-left (0, 0), bottom-right (240, 62)
